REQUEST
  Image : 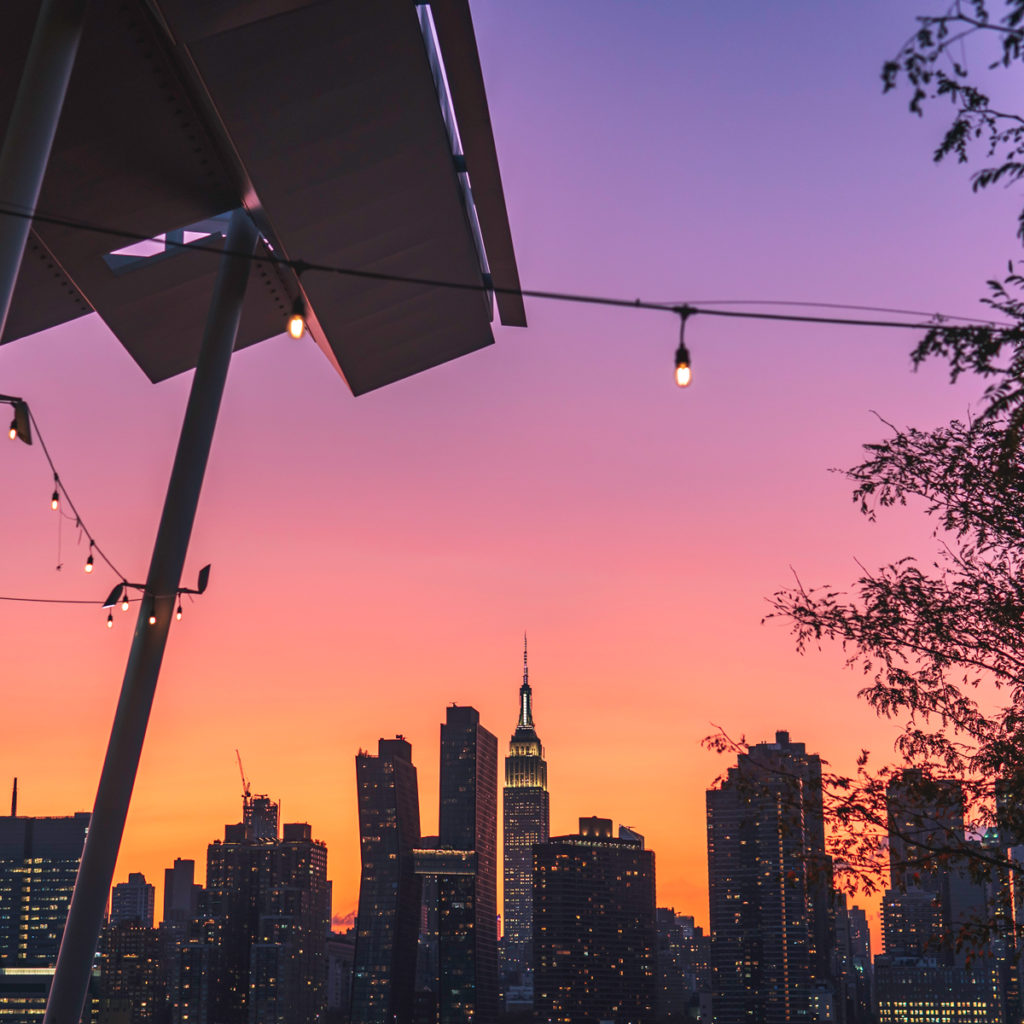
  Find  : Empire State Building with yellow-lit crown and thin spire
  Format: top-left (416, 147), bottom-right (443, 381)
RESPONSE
top-left (502, 635), bottom-right (551, 976)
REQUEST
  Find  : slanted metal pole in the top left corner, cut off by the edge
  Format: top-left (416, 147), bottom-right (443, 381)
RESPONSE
top-left (0, 0), bottom-right (88, 335)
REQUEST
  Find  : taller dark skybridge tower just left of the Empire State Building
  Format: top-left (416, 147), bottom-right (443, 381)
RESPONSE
top-left (432, 705), bottom-right (498, 1024)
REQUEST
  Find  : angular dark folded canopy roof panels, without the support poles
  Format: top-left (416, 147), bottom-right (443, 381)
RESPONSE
top-left (0, 0), bottom-right (525, 395)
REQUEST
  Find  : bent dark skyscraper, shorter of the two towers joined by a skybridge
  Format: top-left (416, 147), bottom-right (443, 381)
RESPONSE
top-left (351, 736), bottom-right (421, 1024)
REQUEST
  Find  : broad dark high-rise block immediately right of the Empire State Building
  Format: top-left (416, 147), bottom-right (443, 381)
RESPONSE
top-left (534, 818), bottom-right (657, 1024)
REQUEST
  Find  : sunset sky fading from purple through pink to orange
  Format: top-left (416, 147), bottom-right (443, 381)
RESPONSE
top-left (0, 0), bottom-right (1020, 942)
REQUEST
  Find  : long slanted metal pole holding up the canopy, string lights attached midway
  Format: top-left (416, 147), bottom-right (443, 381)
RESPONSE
top-left (44, 210), bottom-right (258, 1024)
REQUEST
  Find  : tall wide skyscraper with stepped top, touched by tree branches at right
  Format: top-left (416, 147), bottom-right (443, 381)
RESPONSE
top-left (708, 732), bottom-right (834, 1024)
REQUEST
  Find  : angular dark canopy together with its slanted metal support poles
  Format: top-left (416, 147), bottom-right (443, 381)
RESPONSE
top-left (0, 0), bottom-right (525, 1024)
